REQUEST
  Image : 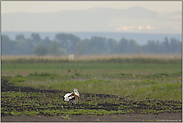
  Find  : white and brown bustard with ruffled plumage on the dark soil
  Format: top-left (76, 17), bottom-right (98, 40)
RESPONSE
top-left (64, 88), bottom-right (79, 104)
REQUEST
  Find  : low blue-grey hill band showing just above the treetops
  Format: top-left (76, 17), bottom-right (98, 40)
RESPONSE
top-left (2, 32), bottom-right (182, 45)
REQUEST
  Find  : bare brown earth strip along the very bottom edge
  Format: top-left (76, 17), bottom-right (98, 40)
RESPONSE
top-left (1, 113), bottom-right (182, 122)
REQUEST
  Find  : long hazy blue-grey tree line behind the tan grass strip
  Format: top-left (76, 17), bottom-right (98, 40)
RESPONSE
top-left (1, 33), bottom-right (182, 56)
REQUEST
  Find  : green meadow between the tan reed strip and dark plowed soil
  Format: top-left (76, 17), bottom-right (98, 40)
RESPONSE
top-left (1, 58), bottom-right (182, 100)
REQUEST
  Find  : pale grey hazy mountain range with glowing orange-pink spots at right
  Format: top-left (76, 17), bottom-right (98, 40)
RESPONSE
top-left (1, 7), bottom-right (181, 33)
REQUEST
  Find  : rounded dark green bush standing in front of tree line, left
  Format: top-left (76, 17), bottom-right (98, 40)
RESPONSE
top-left (34, 46), bottom-right (48, 56)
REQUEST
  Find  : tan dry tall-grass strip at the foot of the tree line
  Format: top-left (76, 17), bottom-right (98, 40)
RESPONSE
top-left (2, 54), bottom-right (181, 64)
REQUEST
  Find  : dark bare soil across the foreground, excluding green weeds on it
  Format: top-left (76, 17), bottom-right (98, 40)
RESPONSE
top-left (1, 79), bottom-right (182, 122)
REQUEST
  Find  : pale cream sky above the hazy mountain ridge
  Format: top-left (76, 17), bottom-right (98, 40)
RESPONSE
top-left (1, 1), bottom-right (182, 13)
